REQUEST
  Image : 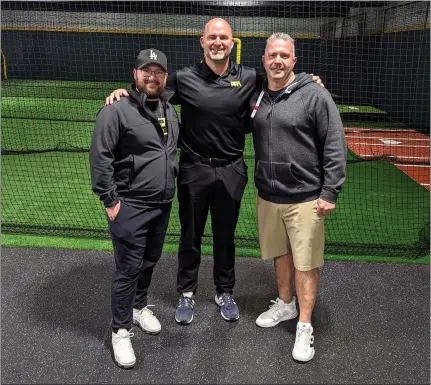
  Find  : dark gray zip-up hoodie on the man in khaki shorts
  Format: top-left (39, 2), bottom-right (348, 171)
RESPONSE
top-left (251, 73), bottom-right (347, 203)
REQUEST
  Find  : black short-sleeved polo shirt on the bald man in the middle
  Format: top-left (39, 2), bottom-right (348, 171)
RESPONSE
top-left (167, 60), bottom-right (261, 159)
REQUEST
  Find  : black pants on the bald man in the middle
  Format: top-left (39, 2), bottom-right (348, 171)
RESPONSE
top-left (177, 158), bottom-right (247, 293)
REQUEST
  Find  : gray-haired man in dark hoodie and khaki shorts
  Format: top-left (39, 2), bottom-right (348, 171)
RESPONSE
top-left (250, 33), bottom-right (347, 362)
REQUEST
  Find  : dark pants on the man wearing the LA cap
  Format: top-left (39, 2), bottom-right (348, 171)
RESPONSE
top-left (108, 202), bottom-right (172, 329)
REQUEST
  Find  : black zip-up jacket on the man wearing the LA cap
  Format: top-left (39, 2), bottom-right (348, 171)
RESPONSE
top-left (90, 90), bottom-right (179, 207)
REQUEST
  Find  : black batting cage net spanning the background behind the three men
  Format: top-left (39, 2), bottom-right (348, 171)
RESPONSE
top-left (1, 1), bottom-right (430, 257)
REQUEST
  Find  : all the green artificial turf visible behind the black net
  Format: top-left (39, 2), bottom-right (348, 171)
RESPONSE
top-left (2, 81), bottom-right (429, 258)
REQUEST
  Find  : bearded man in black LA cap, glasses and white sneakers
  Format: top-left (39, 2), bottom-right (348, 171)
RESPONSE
top-left (90, 48), bottom-right (179, 368)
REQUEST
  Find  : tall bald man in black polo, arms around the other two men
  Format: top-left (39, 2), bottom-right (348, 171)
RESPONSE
top-left (106, 18), bottom-right (320, 324)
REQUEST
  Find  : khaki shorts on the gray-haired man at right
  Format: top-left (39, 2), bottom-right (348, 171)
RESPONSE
top-left (256, 196), bottom-right (325, 271)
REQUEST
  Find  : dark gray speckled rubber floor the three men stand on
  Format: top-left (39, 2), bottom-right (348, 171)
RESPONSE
top-left (1, 247), bottom-right (430, 384)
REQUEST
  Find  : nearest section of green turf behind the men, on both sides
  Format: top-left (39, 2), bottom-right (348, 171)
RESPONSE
top-left (2, 148), bottom-right (429, 254)
